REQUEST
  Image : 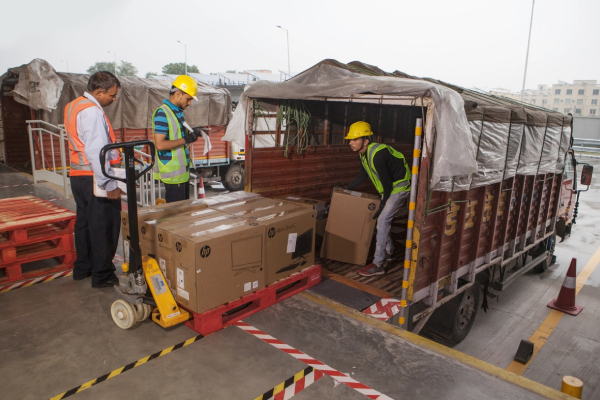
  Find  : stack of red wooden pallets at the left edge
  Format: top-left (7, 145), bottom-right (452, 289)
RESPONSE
top-left (0, 196), bottom-right (76, 283)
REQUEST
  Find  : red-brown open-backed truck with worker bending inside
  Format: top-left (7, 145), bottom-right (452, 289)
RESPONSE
top-left (225, 60), bottom-right (592, 346)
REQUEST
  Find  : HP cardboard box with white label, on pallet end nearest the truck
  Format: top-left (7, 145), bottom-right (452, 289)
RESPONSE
top-left (242, 203), bottom-right (316, 285)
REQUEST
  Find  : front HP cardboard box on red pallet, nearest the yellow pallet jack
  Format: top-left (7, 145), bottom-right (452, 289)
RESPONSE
top-left (165, 216), bottom-right (265, 313)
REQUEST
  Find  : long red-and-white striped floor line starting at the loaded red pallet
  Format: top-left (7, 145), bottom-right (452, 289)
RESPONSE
top-left (233, 321), bottom-right (393, 400)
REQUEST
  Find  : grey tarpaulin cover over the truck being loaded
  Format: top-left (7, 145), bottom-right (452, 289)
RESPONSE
top-left (223, 60), bottom-right (571, 191)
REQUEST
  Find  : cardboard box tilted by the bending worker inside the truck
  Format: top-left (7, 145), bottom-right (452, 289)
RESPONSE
top-left (321, 188), bottom-right (381, 265)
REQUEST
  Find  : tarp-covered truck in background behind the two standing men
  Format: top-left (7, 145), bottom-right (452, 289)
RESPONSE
top-left (0, 59), bottom-right (244, 193)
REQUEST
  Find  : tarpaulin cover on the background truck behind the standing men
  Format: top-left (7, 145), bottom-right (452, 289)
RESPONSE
top-left (0, 59), bottom-right (231, 129)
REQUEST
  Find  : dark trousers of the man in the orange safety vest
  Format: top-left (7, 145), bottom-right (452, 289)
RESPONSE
top-left (71, 176), bottom-right (121, 285)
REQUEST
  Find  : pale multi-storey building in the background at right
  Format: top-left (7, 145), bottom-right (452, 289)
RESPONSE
top-left (489, 80), bottom-right (600, 117)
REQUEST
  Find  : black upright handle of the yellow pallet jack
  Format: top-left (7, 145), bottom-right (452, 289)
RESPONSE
top-left (100, 140), bottom-right (156, 275)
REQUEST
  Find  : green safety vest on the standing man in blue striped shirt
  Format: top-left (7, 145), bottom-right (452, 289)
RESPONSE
top-left (152, 104), bottom-right (190, 184)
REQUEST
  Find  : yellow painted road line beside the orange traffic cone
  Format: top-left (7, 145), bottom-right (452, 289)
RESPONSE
top-left (506, 247), bottom-right (600, 375)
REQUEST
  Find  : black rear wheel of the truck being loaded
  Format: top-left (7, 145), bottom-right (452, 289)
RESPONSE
top-left (421, 282), bottom-right (481, 347)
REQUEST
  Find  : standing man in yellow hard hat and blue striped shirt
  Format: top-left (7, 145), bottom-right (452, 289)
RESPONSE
top-left (152, 75), bottom-right (201, 203)
